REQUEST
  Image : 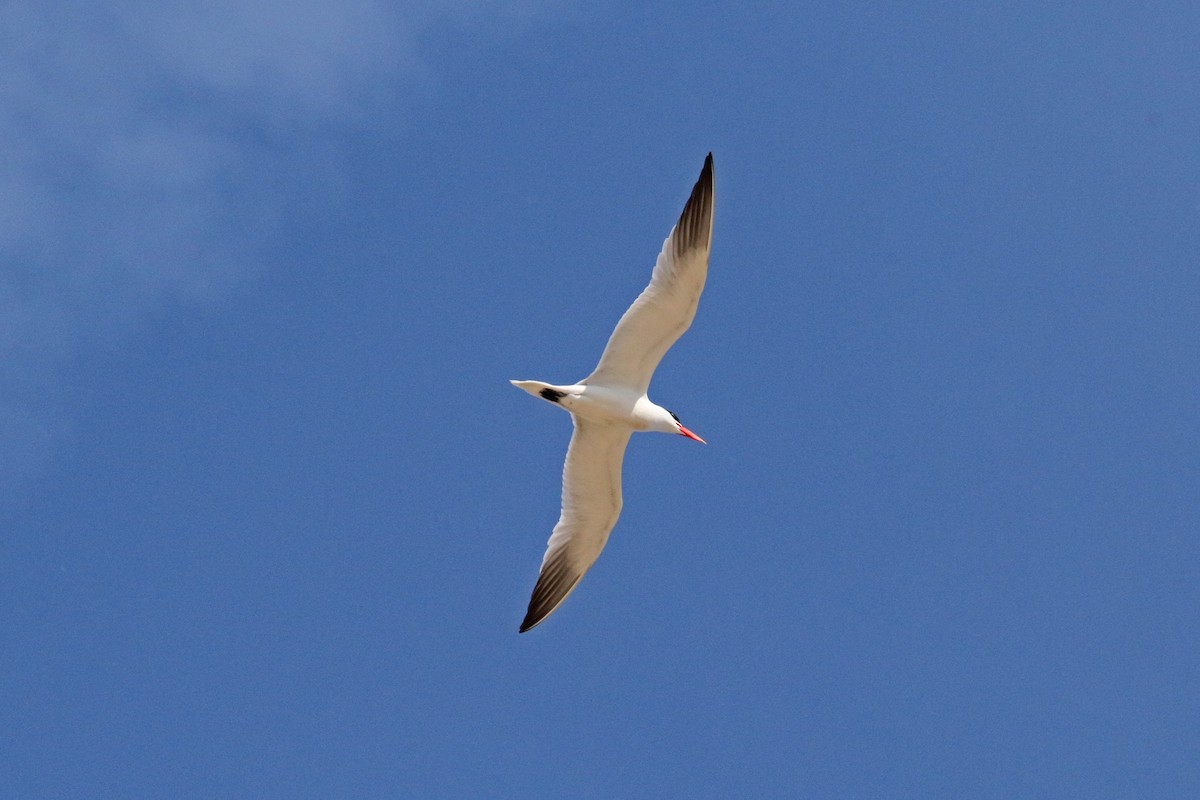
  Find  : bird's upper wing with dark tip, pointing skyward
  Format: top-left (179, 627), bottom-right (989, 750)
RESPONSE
top-left (582, 154), bottom-right (713, 393)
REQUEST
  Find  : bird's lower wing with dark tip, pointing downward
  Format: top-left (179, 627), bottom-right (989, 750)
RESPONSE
top-left (521, 414), bottom-right (632, 633)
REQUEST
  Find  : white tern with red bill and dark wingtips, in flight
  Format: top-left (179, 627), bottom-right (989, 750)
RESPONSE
top-left (510, 154), bottom-right (713, 633)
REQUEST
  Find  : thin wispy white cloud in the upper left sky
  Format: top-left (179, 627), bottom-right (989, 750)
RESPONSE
top-left (0, 0), bottom-right (549, 498)
